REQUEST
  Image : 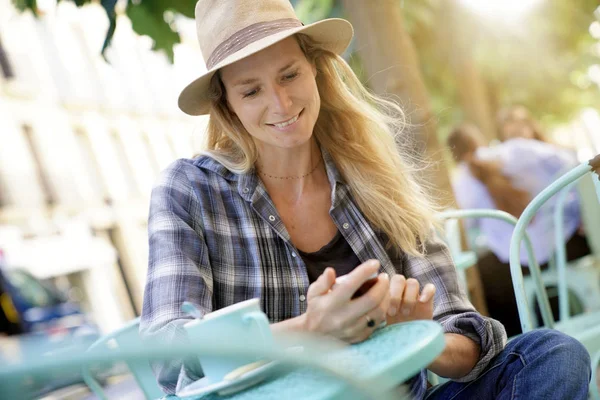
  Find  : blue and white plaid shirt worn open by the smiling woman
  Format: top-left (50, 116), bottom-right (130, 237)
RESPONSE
top-left (140, 152), bottom-right (506, 393)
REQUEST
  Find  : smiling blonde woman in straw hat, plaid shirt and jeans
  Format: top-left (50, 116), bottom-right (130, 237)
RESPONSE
top-left (141, 0), bottom-right (589, 398)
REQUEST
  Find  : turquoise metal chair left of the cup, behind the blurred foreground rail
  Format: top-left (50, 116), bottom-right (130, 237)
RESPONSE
top-left (82, 318), bottom-right (164, 400)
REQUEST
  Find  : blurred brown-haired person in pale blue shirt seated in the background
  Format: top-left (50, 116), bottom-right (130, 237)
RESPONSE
top-left (447, 124), bottom-right (590, 336)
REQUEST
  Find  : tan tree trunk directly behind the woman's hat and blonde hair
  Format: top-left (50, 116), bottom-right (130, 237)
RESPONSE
top-left (342, 0), bottom-right (487, 314)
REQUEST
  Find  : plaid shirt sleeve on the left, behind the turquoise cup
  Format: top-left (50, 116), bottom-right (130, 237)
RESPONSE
top-left (140, 161), bottom-right (213, 394)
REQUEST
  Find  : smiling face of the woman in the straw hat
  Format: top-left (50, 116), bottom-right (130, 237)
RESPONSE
top-left (221, 37), bottom-right (321, 149)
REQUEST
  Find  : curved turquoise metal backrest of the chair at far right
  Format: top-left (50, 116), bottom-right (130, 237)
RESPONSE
top-left (510, 156), bottom-right (600, 332)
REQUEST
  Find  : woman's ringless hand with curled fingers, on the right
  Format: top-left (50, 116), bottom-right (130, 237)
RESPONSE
top-left (387, 275), bottom-right (435, 324)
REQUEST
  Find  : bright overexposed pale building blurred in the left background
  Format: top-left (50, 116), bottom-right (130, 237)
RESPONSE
top-left (0, 0), bottom-right (206, 331)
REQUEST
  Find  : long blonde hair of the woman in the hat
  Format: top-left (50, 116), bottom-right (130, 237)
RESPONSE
top-left (204, 34), bottom-right (437, 256)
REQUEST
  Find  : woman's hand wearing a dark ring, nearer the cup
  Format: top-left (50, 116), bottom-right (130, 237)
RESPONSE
top-left (304, 260), bottom-right (390, 343)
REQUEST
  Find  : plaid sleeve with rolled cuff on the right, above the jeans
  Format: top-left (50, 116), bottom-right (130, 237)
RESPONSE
top-left (404, 238), bottom-right (506, 382)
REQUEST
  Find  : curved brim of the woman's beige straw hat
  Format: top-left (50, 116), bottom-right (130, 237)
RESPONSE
top-left (178, 18), bottom-right (353, 115)
